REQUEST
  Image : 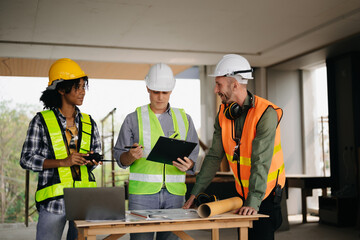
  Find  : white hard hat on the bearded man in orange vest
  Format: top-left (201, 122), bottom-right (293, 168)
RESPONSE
top-left (209, 54), bottom-right (253, 80)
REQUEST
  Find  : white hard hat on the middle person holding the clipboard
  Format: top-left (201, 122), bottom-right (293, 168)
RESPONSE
top-left (145, 63), bottom-right (176, 92)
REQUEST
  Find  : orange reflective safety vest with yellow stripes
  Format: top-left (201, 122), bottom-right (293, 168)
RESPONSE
top-left (219, 96), bottom-right (285, 199)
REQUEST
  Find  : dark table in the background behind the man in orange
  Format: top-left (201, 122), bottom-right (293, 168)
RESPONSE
top-left (286, 175), bottom-right (331, 223)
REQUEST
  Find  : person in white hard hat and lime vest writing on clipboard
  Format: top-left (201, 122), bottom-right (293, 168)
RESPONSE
top-left (114, 63), bottom-right (199, 240)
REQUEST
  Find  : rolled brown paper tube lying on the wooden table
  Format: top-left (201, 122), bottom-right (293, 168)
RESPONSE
top-left (198, 197), bottom-right (243, 218)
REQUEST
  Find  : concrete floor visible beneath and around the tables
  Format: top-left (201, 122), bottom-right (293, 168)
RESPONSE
top-left (0, 215), bottom-right (360, 240)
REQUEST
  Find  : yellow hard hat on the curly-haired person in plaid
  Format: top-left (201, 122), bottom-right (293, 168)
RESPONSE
top-left (47, 58), bottom-right (86, 90)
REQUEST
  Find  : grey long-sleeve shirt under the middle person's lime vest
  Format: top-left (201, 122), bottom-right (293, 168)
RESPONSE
top-left (114, 105), bottom-right (199, 174)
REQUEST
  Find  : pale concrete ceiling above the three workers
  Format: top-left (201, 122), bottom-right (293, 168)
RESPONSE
top-left (0, 0), bottom-right (360, 67)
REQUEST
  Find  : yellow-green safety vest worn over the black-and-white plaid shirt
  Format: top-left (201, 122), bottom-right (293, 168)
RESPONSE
top-left (35, 110), bottom-right (96, 203)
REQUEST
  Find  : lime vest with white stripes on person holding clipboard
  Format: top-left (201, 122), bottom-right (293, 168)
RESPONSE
top-left (129, 105), bottom-right (189, 196)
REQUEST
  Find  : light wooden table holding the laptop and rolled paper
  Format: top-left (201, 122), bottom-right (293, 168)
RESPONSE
top-left (75, 213), bottom-right (267, 240)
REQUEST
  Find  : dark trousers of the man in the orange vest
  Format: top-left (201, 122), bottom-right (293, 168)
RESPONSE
top-left (239, 193), bottom-right (282, 240)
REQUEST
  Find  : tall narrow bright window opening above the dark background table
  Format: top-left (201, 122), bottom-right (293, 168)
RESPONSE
top-left (303, 65), bottom-right (330, 214)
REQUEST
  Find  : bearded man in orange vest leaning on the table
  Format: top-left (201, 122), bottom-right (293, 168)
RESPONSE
top-left (184, 54), bottom-right (285, 240)
